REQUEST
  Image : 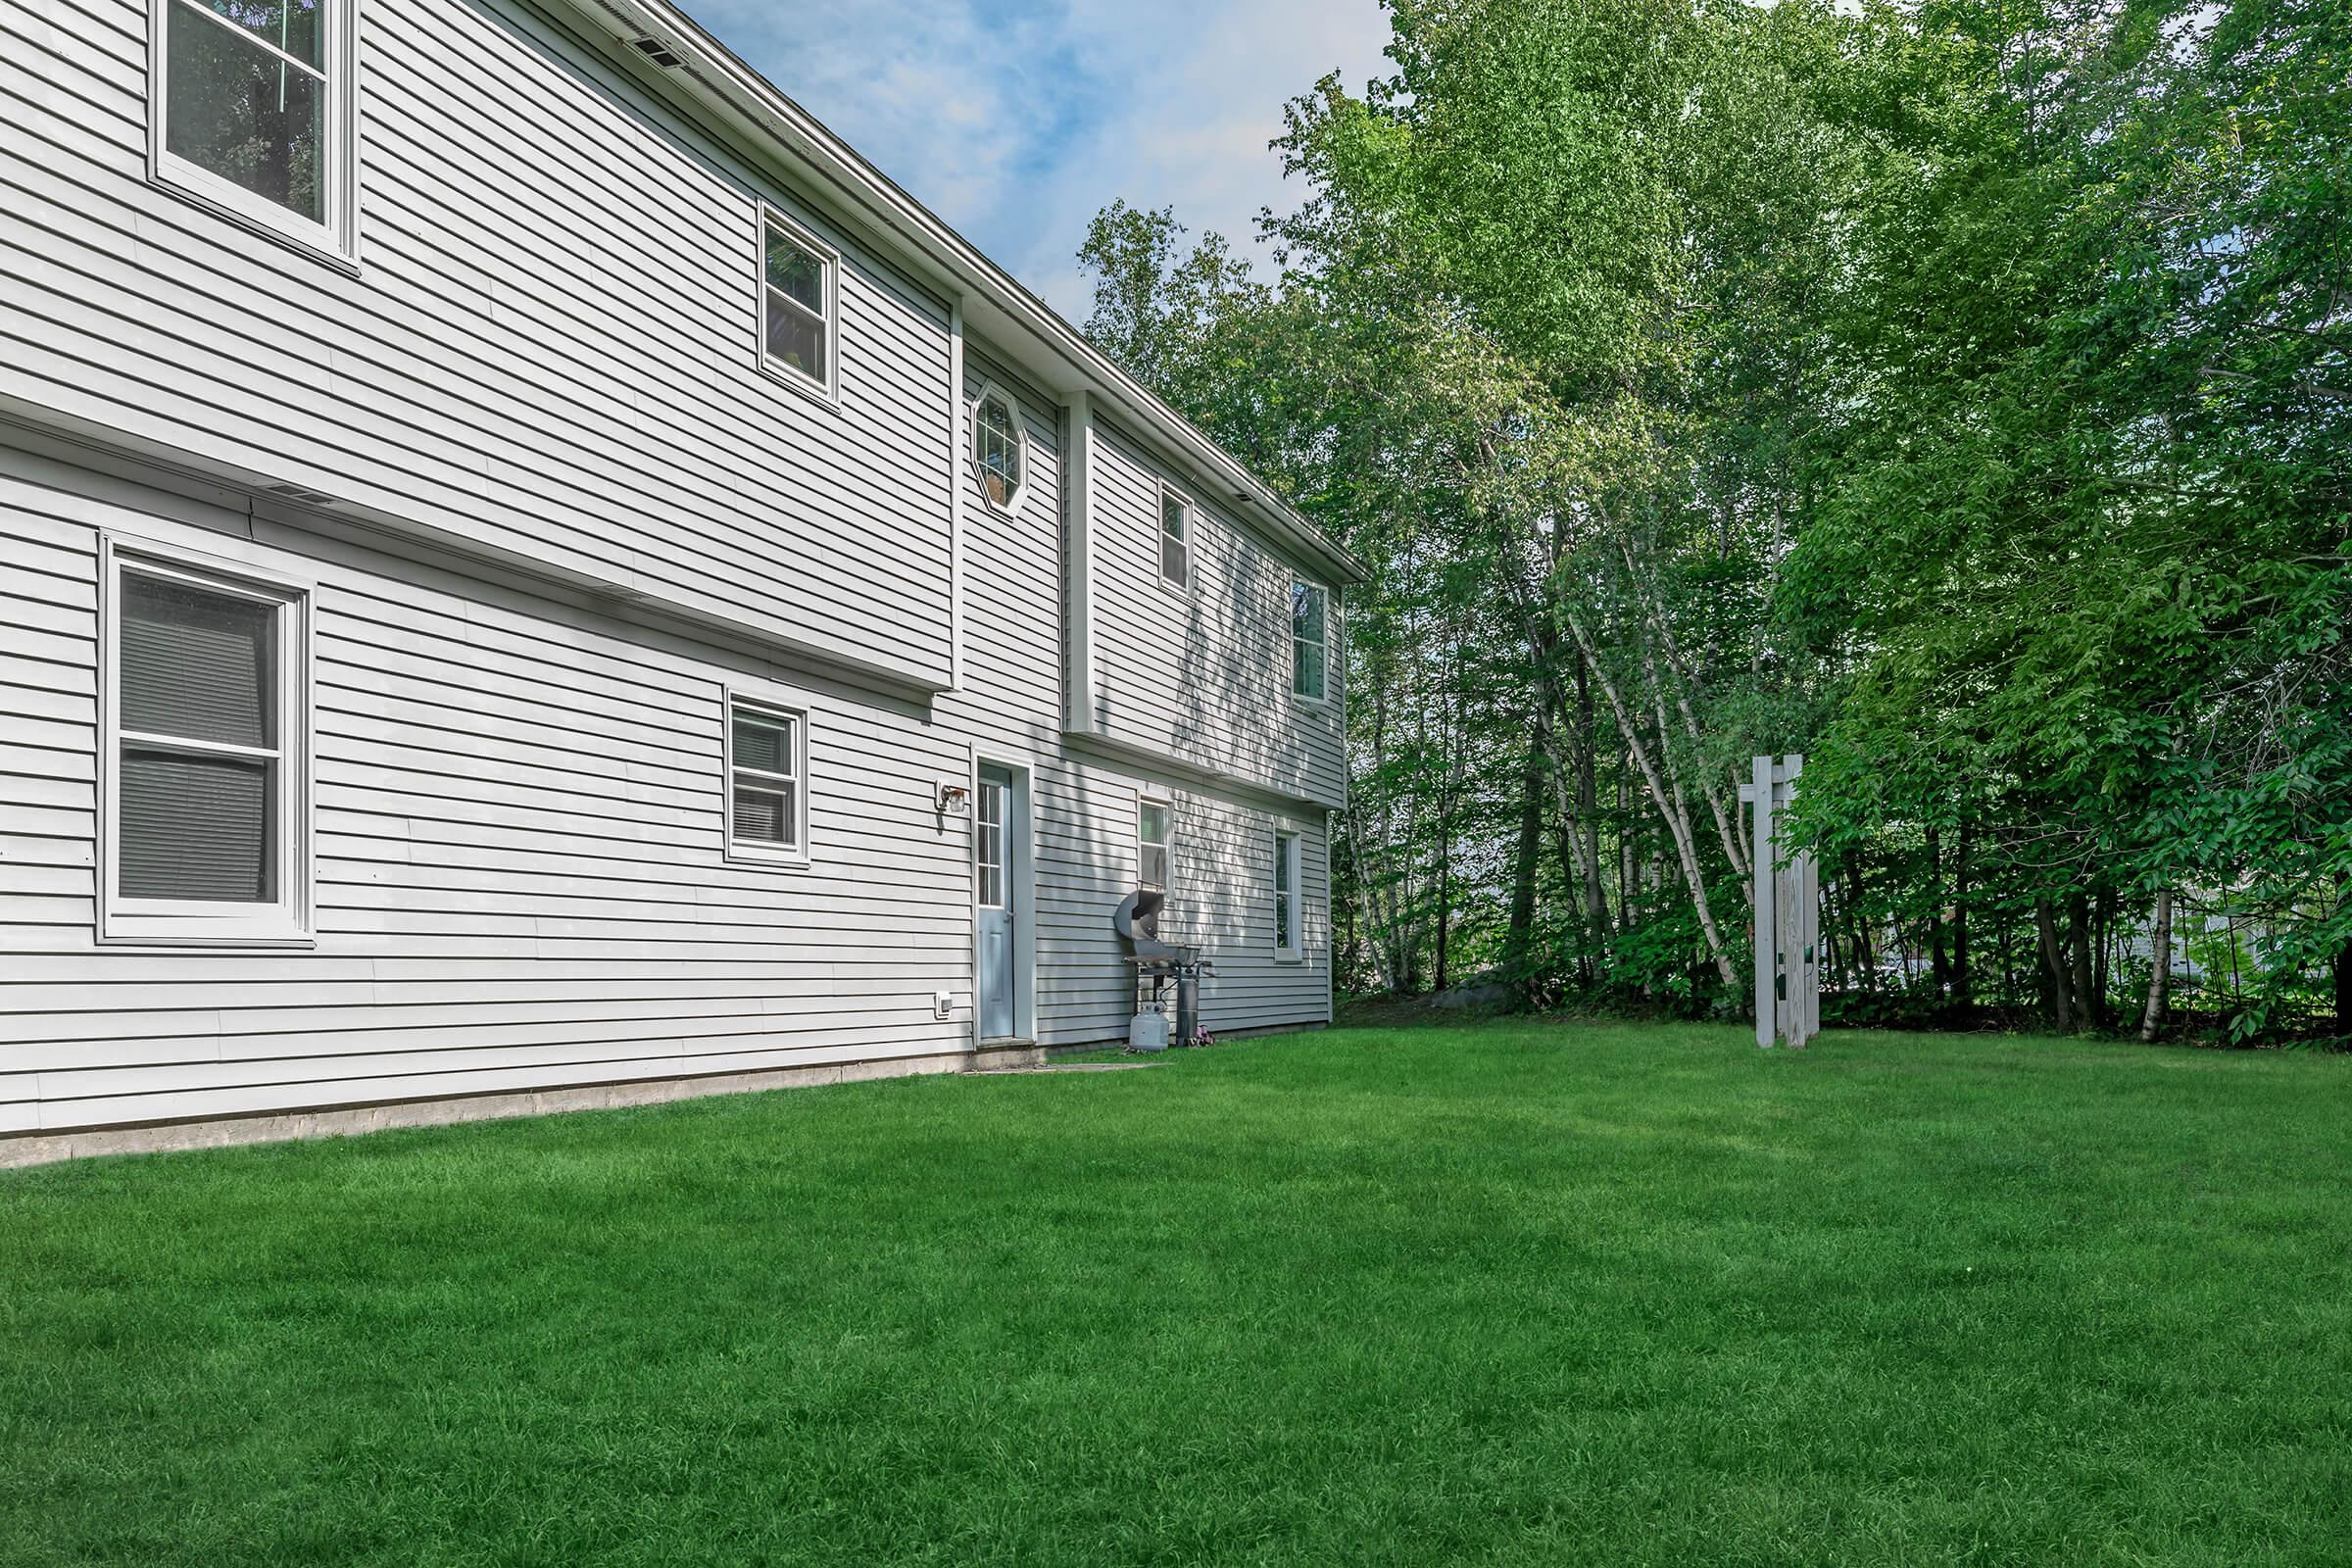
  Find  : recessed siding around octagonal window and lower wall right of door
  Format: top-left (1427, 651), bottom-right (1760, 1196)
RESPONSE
top-left (939, 343), bottom-right (1329, 1046)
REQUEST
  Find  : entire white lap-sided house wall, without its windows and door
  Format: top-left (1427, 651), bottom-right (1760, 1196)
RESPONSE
top-left (0, 0), bottom-right (1343, 1159)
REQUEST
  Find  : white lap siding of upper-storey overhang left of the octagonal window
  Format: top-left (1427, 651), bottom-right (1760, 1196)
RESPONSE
top-left (0, 0), bottom-right (948, 679)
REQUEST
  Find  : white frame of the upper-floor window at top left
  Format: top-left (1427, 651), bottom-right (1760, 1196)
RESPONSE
top-left (146, 0), bottom-right (360, 266)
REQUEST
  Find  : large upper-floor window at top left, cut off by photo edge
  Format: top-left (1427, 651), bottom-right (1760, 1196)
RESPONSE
top-left (148, 0), bottom-right (358, 254)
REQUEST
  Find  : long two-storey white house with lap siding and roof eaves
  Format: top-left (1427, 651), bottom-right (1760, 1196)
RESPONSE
top-left (0, 0), bottom-right (1362, 1161)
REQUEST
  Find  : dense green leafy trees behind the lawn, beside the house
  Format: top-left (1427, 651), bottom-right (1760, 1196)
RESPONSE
top-left (1084, 0), bottom-right (2352, 1039)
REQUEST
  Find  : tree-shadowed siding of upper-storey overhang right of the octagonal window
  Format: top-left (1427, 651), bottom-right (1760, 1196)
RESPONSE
top-left (1094, 423), bottom-right (1343, 807)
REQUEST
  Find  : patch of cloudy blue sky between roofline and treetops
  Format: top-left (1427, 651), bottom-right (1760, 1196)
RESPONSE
top-left (684, 0), bottom-right (1388, 319)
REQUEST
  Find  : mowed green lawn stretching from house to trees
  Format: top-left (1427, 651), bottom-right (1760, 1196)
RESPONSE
top-left (0, 1022), bottom-right (2352, 1568)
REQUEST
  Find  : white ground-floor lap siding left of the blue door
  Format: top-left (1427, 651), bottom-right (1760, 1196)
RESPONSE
top-left (0, 461), bottom-right (971, 1131)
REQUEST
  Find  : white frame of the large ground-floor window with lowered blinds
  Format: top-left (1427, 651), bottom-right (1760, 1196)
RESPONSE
top-left (96, 534), bottom-right (318, 948)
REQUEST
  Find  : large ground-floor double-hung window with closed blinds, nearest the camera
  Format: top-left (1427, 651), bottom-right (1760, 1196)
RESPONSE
top-left (99, 548), bottom-right (311, 943)
